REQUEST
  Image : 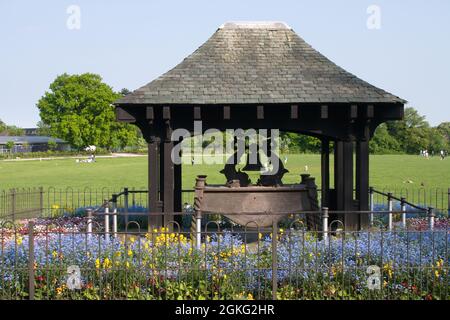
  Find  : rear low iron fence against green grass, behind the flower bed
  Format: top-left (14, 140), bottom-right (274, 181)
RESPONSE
top-left (0, 187), bottom-right (450, 220)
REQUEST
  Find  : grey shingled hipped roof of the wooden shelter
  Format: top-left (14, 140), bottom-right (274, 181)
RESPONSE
top-left (116, 22), bottom-right (405, 105)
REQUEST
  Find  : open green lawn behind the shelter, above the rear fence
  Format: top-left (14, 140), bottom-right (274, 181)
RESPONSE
top-left (0, 154), bottom-right (450, 190)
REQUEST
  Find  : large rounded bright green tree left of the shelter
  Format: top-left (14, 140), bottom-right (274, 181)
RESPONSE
top-left (37, 73), bottom-right (137, 150)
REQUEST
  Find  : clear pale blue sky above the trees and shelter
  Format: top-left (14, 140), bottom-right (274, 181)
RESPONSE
top-left (0, 0), bottom-right (450, 127)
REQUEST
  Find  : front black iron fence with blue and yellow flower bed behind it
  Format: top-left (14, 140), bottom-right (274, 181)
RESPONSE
top-left (0, 209), bottom-right (450, 299)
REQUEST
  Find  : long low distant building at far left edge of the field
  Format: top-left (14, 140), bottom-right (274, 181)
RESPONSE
top-left (0, 135), bottom-right (70, 153)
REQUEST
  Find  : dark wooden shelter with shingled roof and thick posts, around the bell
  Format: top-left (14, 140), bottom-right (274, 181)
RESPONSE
top-left (115, 22), bottom-right (405, 230)
